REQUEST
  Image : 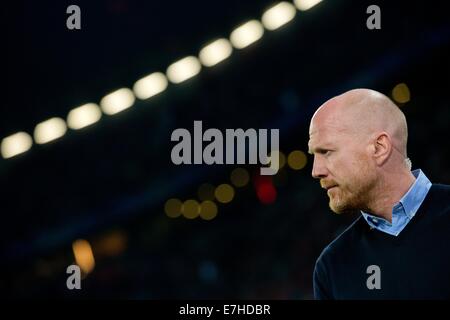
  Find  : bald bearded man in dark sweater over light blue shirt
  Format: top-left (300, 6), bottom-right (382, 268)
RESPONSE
top-left (309, 89), bottom-right (450, 299)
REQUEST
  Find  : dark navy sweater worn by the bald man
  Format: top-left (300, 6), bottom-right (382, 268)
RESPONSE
top-left (313, 184), bottom-right (450, 299)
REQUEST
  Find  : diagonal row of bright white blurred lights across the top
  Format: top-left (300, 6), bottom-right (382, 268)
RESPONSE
top-left (0, 0), bottom-right (322, 159)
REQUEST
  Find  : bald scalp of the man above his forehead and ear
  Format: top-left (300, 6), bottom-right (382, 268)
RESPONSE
top-left (310, 89), bottom-right (408, 158)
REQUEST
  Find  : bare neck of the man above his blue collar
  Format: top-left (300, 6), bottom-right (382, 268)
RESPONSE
top-left (368, 170), bottom-right (416, 223)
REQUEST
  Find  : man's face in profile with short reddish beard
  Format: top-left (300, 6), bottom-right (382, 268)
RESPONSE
top-left (308, 119), bottom-right (376, 213)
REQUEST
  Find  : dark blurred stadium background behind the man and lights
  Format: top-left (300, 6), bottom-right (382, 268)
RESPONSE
top-left (0, 0), bottom-right (450, 299)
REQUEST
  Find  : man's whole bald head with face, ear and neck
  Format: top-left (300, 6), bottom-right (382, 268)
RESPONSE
top-left (308, 89), bottom-right (415, 221)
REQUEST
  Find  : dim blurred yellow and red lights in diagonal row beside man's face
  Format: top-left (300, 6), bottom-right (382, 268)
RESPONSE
top-left (164, 150), bottom-right (307, 220)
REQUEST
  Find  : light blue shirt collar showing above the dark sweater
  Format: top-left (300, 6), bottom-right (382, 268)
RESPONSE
top-left (361, 169), bottom-right (431, 236)
